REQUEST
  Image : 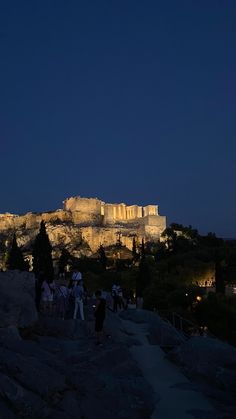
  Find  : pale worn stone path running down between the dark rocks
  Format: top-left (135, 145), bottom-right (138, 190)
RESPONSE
top-left (122, 319), bottom-right (214, 419)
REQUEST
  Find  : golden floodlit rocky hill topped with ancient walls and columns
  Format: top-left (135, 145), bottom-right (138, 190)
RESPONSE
top-left (0, 196), bottom-right (166, 256)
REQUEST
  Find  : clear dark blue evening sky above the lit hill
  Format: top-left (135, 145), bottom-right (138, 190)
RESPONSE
top-left (0, 0), bottom-right (236, 237)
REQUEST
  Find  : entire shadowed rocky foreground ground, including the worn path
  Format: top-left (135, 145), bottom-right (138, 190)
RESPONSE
top-left (0, 274), bottom-right (236, 419)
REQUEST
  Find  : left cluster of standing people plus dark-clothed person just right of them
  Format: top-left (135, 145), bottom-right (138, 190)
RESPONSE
top-left (35, 270), bottom-right (106, 344)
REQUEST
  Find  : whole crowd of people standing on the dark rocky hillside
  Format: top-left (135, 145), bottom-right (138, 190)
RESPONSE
top-left (35, 270), bottom-right (131, 343)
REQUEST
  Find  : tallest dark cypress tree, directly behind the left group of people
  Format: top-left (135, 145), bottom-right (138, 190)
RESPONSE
top-left (33, 221), bottom-right (54, 281)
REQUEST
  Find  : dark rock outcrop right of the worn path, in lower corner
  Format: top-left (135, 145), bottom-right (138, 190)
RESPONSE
top-left (168, 336), bottom-right (236, 419)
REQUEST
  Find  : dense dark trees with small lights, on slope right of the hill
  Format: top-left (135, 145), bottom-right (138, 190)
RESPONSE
top-left (63, 224), bottom-right (236, 344)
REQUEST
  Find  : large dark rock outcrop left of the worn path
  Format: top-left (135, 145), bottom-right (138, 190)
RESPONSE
top-left (0, 272), bottom-right (153, 419)
